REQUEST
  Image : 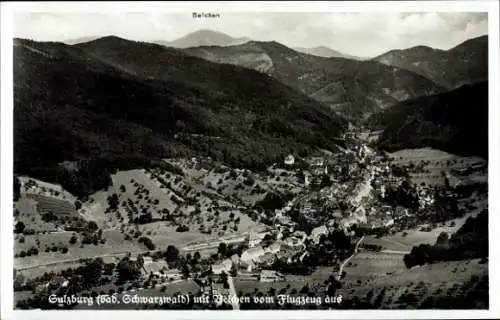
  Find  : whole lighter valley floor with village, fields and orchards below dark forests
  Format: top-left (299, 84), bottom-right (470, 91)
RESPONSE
top-left (15, 127), bottom-right (487, 308)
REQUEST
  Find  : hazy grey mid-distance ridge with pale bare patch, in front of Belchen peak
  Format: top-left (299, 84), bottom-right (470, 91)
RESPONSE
top-left (183, 41), bottom-right (444, 121)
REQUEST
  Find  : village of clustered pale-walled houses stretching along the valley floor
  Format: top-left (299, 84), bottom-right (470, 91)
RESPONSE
top-left (17, 127), bottom-right (481, 309)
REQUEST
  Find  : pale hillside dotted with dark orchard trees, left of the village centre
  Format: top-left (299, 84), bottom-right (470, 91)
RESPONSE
top-left (75, 170), bottom-right (266, 240)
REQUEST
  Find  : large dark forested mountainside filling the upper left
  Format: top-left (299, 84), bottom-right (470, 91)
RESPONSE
top-left (14, 37), bottom-right (347, 196)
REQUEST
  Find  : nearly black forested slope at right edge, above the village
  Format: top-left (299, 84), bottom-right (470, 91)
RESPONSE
top-left (368, 82), bottom-right (488, 159)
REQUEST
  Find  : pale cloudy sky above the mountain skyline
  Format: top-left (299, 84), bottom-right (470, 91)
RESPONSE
top-left (14, 11), bottom-right (488, 57)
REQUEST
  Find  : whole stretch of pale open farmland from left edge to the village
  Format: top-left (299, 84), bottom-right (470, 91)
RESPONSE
top-left (14, 165), bottom-right (270, 276)
